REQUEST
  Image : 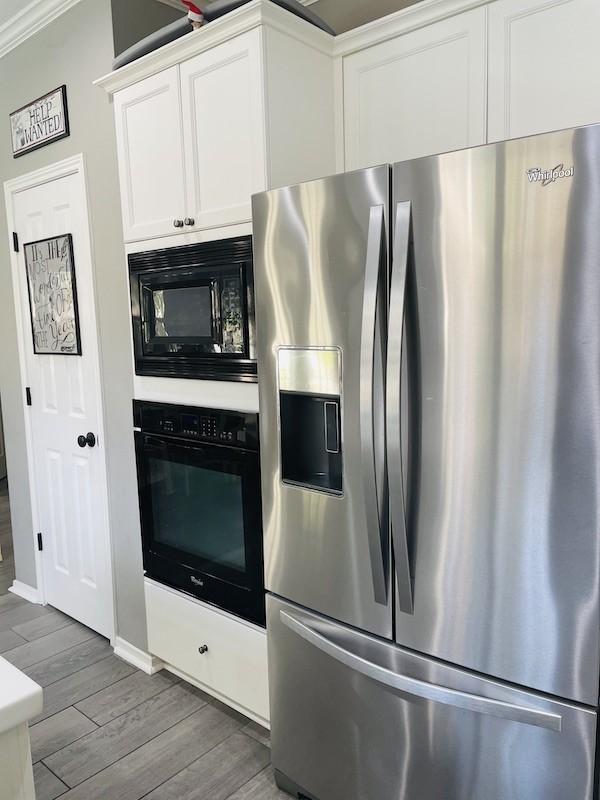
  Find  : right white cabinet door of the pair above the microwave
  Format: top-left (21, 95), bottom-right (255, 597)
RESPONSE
top-left (180, 30), bottom-right (267, 228)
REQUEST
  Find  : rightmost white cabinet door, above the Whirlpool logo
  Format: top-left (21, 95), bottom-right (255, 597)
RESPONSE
top-left (489, 0), bottom-right (600, 142)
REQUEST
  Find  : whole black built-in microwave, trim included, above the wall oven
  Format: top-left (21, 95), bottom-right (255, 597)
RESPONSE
top-left (128, 236), bottom-right (256, 382)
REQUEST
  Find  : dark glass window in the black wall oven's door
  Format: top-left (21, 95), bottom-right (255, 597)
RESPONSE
top-left (148, 458), bottom-right (246, 572)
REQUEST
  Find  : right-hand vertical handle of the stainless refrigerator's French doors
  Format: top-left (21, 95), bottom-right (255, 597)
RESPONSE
top-left (386, 201), bottom-right (414, 614)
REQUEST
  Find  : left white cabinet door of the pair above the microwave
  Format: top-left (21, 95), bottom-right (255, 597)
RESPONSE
top-left (115, 67), bottom-right (186, 242)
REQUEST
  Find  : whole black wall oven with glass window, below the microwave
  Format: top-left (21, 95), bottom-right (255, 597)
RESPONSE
top-left (134, 401), bottom-right (265, 625)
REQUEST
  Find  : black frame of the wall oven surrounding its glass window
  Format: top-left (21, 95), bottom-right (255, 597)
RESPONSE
top-left (133, 400), bottom-right (265, 627)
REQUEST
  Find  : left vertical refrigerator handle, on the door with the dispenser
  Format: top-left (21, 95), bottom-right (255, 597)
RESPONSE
top-left (360, 206), bottom-right (388, 605)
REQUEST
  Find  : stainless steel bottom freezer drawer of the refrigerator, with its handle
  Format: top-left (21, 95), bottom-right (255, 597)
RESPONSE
top-left (267, 596), bottom-right (596, 800)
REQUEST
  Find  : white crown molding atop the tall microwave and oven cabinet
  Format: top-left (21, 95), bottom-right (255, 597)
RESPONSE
top-left (94, 0), bottom-right (334, 94)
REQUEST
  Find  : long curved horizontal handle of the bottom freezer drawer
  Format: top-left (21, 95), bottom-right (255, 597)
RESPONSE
top-left (279, 609), bottom-right (562, 733)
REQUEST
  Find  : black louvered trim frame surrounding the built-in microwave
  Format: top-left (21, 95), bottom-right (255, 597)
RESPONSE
top-left (128, 236), bottom-right (257, 383)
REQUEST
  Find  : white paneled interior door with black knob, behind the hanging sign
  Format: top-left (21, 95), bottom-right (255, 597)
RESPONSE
top-left (11, 164), bottom-right (113, 637)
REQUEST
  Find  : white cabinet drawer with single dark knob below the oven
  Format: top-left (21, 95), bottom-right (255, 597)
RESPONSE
top-left (145, 580), bottom-right (269, 725)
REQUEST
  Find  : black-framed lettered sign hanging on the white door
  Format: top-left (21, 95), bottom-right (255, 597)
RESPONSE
top-left (23, 233), bottom-right (81, 356)
